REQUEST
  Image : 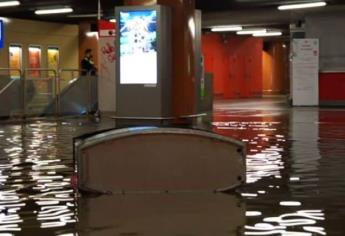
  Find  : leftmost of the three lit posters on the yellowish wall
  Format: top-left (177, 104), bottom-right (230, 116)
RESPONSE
top-left (8, 44), bottom-right (23, 79)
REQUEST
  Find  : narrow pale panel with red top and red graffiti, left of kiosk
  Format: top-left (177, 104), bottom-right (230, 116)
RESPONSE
top-left (98, 20), bottom-right (116, 112)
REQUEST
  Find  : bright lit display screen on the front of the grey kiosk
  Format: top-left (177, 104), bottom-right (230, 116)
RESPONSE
top-left (120, 10), bottom-right (157, 84)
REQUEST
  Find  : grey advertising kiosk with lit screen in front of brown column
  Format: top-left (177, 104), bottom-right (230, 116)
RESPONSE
top-left (116, 5), bottom-right (172, 120)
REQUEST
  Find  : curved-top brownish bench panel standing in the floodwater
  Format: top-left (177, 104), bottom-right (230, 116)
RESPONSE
top-left (74, 127), bottom-right (245, 193)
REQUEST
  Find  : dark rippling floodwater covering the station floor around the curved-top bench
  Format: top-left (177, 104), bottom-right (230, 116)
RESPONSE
top-left (0, 97), bottom-right (345, 236)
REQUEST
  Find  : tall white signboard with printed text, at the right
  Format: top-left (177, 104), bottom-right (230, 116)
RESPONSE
top-left (292, 39), bottom-right (320, 106)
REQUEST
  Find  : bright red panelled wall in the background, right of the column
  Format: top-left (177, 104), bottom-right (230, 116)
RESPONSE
top-left (203, 33), bottom-right (263, 98)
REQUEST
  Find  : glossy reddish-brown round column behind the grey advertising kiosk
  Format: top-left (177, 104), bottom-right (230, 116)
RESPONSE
top-left (125, 0), bottom-right (196, 116)
